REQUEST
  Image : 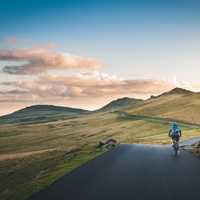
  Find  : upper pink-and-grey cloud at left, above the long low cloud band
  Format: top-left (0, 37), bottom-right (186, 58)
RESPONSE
top-left (0, 48), bottom-right (102, 75)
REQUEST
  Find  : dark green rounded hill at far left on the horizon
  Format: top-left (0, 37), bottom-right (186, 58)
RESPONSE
top-left (0, 105), bottom-right (89, 124)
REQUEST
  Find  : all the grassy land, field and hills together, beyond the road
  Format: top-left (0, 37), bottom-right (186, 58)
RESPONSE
top-left (0, 88), bottom-right (200, 200)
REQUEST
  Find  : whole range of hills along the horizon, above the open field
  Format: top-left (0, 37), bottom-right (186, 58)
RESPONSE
top-left (0, 88), bottom-right (200, 124)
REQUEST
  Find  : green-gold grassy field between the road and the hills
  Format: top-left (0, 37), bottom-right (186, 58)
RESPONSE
top-left (0, 112), bottom-right (200, 200)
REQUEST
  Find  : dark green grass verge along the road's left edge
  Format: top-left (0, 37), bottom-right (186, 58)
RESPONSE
top-left (0, 148), bottom-right (104, 200)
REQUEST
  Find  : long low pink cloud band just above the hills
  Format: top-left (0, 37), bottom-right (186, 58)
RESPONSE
top-left (0, 72), bottom-right (174, 102)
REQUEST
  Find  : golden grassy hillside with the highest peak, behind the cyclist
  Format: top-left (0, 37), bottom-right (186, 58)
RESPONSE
top-left (125, 88), bottom-right (200, 124)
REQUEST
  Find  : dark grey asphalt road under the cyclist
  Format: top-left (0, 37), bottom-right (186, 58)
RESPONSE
top-left (31, 145), bottom-right (200, 200)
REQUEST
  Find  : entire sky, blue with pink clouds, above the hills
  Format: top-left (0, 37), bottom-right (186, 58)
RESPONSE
top-left (0, 0), bottom-right (200, 115)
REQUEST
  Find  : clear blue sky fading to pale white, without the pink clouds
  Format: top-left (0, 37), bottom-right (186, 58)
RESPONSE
top-left (0, 0), bottom-right (200, 114)
